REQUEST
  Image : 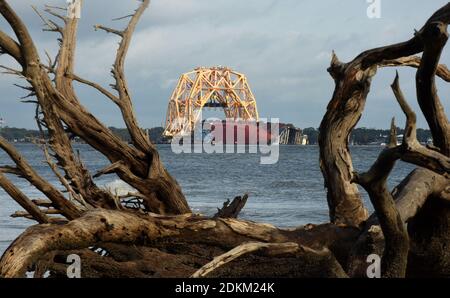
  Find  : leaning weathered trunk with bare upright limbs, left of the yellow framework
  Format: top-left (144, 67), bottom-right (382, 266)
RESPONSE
top-left (0, 0), bottom-right (190, 214)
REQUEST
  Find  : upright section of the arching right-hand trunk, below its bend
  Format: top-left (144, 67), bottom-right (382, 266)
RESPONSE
top-left (319, 53), bottom-right (375, 226)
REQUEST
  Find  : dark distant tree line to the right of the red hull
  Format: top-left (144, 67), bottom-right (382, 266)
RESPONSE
top-left (303, 127), bottom-right (431, 145)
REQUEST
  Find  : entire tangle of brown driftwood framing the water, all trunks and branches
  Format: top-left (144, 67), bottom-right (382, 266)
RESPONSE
top-left (0, 0), bottom-right (450, 277)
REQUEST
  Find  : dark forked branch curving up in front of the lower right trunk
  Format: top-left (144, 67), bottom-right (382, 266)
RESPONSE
top-left (353, 73), bottom-right (450, 277)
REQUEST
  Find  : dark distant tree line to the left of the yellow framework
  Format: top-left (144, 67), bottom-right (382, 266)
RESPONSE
top-left (0, 126), bottom-right (168, 144)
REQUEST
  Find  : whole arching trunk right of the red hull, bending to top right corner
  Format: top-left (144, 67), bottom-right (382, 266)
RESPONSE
top-left (319, 5), bottom-right (449, 225)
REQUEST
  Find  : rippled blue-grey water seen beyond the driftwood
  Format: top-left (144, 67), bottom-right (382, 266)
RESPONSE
top-left (0, 144), bottom-right (412, 253)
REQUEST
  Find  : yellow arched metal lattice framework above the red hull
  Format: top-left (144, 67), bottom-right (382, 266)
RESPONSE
top-left (164, 67), bottom-right (259, 137)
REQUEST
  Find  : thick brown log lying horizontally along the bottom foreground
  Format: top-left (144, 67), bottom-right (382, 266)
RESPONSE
top-left (0, 209), bottom-right (359, 277)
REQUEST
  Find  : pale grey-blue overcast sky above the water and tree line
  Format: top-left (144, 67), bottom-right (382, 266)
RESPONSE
top-left (0, 0), bottom-right (450, 128)
